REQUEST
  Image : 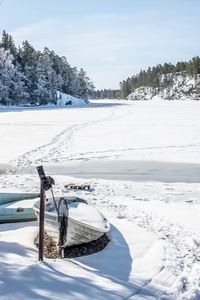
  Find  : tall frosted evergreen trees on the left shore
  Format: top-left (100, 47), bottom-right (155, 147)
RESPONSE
top-left (0, 31), bottom-right (94, 105)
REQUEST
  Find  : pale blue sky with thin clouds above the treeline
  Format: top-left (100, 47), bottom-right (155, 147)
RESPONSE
top-left (0, 0), bottom-right (200, 88)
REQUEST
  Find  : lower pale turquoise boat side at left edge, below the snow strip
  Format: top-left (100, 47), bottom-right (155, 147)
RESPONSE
top-left (0, 207), bottom-right (36, 223)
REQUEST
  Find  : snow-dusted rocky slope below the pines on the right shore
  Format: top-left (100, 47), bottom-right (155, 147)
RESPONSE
top-left (127, 73), bottom-right (200, 100)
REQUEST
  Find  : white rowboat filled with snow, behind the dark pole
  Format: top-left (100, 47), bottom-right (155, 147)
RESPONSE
top-left (33, 196), bottom-right (110, 247)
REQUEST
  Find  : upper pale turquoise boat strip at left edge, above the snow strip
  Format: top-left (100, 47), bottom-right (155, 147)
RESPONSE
top-left (0, 192), bottom-right (39, 205)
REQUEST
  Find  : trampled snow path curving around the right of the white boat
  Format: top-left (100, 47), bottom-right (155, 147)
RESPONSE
top-left (89, 187), bottom-right (199, 300)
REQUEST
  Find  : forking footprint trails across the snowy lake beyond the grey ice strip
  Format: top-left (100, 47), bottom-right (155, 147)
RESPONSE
top-left (10, 107), bottom-right (198, 167)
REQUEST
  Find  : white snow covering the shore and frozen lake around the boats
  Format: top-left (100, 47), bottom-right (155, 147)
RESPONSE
top-left (0, 100), bottom-right (200, 300)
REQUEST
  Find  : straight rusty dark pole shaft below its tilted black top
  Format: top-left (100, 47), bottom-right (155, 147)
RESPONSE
top-left (39, 179), bottom-right (45, 261)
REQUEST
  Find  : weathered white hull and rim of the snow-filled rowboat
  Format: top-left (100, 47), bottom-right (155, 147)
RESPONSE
top-left (33, 197), bottom-right (110, 247)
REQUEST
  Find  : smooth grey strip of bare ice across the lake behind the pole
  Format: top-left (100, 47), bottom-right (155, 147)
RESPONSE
top-left (17, 159), bottom-right (200, 183)
